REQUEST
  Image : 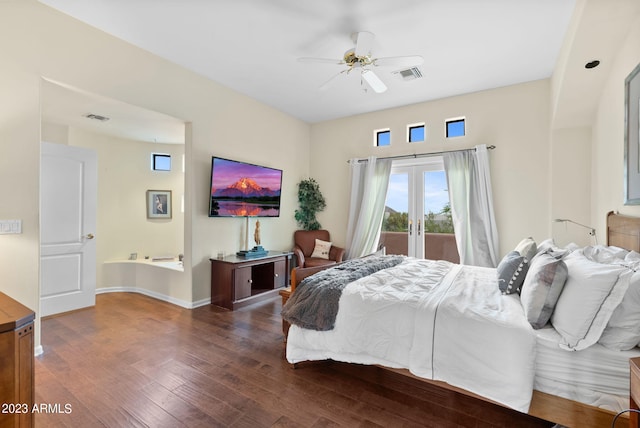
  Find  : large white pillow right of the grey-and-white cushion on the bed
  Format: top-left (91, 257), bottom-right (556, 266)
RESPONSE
top-left (551, 251), bottom-right (632, 351)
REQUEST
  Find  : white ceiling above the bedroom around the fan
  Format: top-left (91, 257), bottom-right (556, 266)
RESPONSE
top-left (40, 0), bottom-right (575, 139)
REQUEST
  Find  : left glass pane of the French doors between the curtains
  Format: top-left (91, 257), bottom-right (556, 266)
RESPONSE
top-left (380, 173), bottom-right (409, 255)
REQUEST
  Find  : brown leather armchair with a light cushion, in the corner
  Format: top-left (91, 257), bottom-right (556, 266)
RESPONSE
top-left (293, 230), bottom-right (344, 268)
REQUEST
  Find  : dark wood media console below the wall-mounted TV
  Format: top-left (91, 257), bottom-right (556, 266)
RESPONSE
top-left (209, 251), bottom-right (293, 310)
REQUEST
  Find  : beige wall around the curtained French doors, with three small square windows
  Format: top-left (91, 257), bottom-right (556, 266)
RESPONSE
top-left (311, 80), bottom-right (550, 253)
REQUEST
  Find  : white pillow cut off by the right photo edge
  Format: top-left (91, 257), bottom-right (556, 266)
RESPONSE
top-left (598, 272), bottom-right (640, 351)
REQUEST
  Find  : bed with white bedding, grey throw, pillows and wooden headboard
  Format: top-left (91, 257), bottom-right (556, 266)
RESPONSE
top-left (283, 213), bottom-right (640, 426)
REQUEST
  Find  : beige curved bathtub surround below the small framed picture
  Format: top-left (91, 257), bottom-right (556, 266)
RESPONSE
top-left (96, 257), bottom-right (195, 308)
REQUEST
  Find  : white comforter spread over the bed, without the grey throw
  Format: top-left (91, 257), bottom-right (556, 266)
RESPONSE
top-left (287, 258), bottom-right (536, 412)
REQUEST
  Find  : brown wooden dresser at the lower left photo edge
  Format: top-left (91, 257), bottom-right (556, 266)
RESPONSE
top-left (0, 293), bottom-right (35, 428)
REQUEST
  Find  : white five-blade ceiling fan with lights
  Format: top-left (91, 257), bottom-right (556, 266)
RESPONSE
top-left (298, 31), bottom-right (424, 93)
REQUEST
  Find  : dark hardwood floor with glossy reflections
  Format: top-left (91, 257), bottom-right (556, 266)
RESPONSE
top-left (35, 293), bottom-right (553, 428)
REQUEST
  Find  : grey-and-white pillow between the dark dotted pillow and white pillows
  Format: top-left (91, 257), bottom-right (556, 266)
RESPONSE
top-left (520, 253), bottom-right (567, 329)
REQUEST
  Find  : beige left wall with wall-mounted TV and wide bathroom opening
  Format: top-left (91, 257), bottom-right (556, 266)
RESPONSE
top-left (0, 0), bottom-right (310, 344)
